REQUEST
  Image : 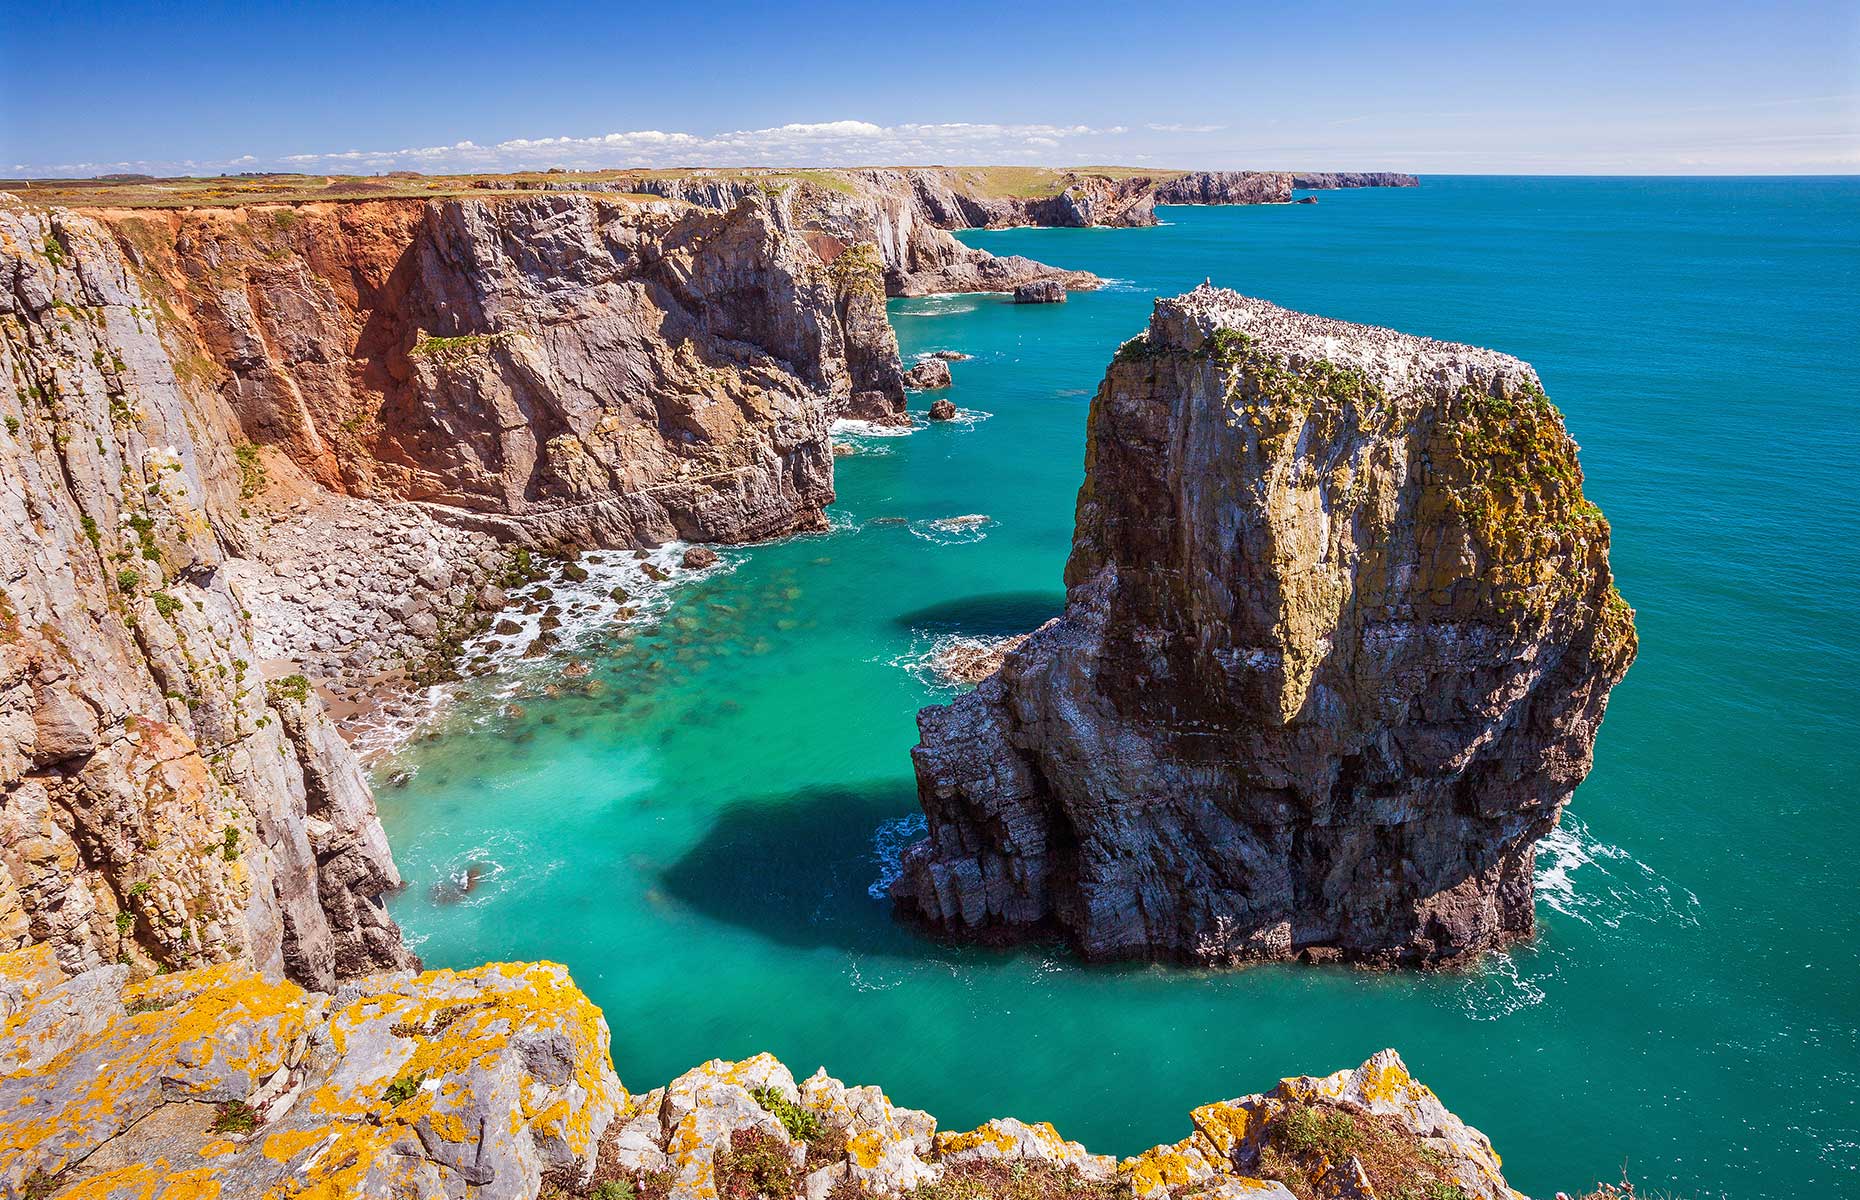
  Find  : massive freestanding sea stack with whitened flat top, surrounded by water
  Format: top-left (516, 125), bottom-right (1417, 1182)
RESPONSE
top-left (895, 288), bottom-right (1635, 964)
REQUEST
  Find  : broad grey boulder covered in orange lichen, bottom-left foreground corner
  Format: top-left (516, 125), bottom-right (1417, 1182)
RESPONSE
top-left (0, 947), bottom-right (627, 1200)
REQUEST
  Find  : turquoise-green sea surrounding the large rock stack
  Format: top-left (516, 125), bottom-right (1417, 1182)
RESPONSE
top-left (378, 179), bottom-right (1860, 1196)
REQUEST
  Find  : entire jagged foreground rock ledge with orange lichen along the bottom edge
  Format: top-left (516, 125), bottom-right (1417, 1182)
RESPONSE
top-left (0, 947), bottom-right (1516, 1200)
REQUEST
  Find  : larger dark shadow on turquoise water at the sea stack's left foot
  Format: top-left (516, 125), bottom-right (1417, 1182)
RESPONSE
top-left (660, 780), bottom-right (1053, 962)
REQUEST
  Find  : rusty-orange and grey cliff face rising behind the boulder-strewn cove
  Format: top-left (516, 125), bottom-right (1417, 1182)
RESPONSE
top-left (110, 195), bottom-right (904, 545)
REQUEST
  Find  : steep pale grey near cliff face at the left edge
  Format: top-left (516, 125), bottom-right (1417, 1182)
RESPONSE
top-left (0, 207), bottom-right (409, 984)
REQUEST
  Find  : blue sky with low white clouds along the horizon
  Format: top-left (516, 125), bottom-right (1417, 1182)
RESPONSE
top-left (0, 0), bottom-right (1860, 175)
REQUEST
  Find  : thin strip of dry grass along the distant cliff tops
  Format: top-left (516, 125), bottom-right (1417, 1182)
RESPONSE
top-left (0, 167), bottom-right (1181, 208)
